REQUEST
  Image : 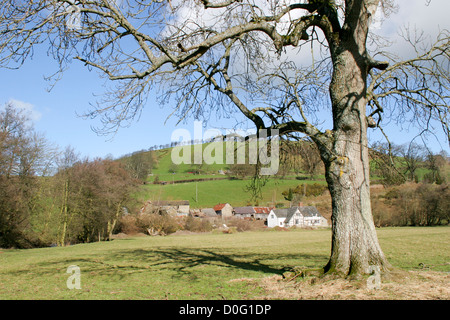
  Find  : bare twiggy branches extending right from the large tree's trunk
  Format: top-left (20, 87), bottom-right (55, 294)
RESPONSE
top-left (368, 30), bottom-right (450, 142)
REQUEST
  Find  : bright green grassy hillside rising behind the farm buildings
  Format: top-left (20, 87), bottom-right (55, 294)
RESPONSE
top-left (129, 143), bottom-right (326, 208)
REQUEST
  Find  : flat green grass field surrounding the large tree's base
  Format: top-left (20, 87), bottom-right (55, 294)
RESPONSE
top-left (0, 227), bottom-right (450, 299)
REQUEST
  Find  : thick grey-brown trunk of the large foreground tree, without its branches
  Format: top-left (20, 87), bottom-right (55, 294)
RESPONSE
top-left (322, 34), bottom-right (389, 276)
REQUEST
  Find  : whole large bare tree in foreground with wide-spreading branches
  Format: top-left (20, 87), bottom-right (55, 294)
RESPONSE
top-left (0, 0), bottom-right (449, 276)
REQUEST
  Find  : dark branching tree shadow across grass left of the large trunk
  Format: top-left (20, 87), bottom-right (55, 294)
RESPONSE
top-left (1, 247), bottom-right (327, 278)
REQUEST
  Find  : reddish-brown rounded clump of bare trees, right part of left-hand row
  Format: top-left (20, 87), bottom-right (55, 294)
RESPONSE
top-left (54, 156), bottom-right (137, 246)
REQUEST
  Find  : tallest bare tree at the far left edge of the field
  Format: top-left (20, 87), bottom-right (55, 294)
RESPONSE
top-left (0, 103), bottom-right (56, 247)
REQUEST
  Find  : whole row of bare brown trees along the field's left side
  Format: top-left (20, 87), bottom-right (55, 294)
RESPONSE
top-left (0, 104), bottom-right (138, 248)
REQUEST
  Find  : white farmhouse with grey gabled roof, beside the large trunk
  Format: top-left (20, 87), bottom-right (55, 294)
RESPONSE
top-left (267, 206), bottom-right (328, 228)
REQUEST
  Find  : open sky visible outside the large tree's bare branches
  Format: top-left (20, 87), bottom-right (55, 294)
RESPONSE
top-left (0, 0), bottom-right (450, 158)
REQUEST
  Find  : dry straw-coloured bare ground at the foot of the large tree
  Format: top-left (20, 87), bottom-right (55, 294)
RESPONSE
top-left (246, 271), bottom-right (450, 300)
